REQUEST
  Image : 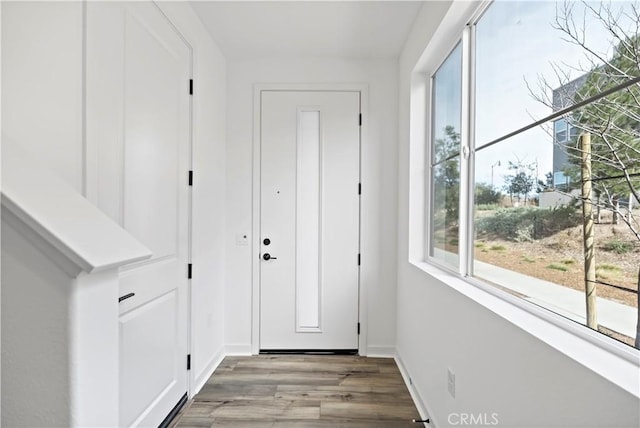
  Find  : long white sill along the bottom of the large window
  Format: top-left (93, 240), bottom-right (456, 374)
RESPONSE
top-left (410, 260), bottom-right (640, 398)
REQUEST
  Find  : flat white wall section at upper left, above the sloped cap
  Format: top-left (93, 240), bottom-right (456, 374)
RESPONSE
top-left (1, 2), bottom-right (83, 191)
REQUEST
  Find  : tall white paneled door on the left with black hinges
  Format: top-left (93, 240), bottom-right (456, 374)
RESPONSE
top-left (87, 2), bottom-right (191, 426)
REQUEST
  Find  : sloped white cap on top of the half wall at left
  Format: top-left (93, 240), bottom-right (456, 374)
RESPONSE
top-left (1, 147), bottom-right (151, 276)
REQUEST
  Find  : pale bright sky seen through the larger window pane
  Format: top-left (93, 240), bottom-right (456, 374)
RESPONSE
top-left (468, 0), bottom-right (633, 187)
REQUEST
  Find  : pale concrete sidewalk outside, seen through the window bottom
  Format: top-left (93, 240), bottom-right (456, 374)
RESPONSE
top-left (474, 260), bottom-right (638, 338)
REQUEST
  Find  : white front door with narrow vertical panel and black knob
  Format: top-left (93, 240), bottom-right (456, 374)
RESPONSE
top-left (260, 90), bottom-right (360, 351)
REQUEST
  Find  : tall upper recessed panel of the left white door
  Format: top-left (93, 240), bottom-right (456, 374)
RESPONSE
top-left (123, 11), bottom-right (185, 259)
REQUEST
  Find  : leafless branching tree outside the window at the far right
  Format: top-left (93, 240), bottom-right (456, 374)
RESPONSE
top-left (529, 1), bottom-right (640, 349)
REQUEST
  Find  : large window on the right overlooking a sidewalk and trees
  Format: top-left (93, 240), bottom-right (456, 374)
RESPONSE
top-left (427, 0), bottom-right (640, 346)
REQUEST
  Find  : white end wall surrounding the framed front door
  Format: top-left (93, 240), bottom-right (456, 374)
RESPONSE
top-left (225, 58), bottom-right (397, 354)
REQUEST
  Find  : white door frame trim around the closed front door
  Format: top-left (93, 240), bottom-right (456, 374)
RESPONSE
top-left (251, 83), bottom-right (369, 356)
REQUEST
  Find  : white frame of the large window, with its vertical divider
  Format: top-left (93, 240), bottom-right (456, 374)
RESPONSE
top-left (420, 0), bottom-right (640, 364)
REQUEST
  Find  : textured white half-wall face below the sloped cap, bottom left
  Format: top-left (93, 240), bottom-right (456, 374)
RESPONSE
top-left (2, 220), bottom-right (74, 426)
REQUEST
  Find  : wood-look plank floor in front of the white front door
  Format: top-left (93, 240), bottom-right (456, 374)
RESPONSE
top-left (173, 355), bottom-right (422, 428)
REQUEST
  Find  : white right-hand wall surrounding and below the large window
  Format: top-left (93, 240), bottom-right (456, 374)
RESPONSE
top-left (397, 2), bottom-right (640, 427)
